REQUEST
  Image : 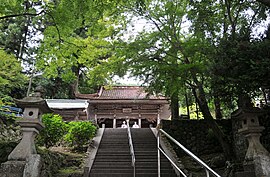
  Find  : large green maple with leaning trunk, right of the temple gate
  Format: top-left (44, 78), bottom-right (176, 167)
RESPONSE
top-left (116, 0), bottom-right (270, 159)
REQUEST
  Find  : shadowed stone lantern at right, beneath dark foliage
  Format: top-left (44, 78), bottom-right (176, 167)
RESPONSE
top-left (233, 107), bottom-right (270, 177)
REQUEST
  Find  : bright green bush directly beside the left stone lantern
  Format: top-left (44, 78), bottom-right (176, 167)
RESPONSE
top-left (37, 114), bottom-right (67, 148)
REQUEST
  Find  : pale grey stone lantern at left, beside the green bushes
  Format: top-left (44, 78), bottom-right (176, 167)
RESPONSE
top-left (0, 87), bottom-right (52, 177)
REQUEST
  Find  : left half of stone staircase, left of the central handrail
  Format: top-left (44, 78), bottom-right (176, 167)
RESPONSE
top-left (89, 128), bottom-right (133, 177)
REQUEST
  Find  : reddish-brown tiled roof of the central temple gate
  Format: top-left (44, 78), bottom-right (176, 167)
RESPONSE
top-left (96, 86), bottom-right (166, 99)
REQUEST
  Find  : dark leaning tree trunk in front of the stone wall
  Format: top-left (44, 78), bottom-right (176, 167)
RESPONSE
top-left (192, 78), bottom-right (233, 160)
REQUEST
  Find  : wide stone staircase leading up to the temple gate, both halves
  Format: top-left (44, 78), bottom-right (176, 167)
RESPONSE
top-left (89, 128), bottom-right (176, 177)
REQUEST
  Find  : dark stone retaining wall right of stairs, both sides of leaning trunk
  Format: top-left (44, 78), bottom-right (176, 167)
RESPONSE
top-left (162, 109), bottom-right (270, 162)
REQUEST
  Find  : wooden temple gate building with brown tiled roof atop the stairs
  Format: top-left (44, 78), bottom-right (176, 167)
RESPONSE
top-left (76, 86), bottom-right (170, 128)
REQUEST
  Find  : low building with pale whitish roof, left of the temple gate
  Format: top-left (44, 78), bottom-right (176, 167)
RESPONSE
top-left (46, 99), bottom-right (89, 121)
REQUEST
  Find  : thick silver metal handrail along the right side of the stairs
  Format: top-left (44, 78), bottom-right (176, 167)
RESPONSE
top-left (157, 129), bottom-right (221, 177)
